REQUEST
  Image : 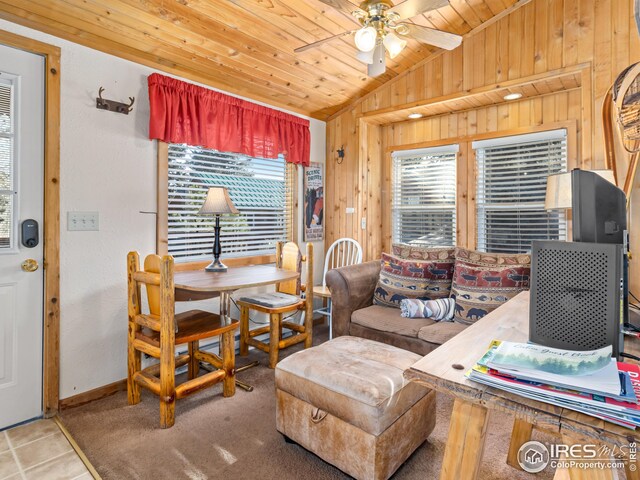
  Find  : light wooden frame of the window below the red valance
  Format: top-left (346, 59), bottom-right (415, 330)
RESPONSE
top-left (156, 141), bottom-right (299, 271)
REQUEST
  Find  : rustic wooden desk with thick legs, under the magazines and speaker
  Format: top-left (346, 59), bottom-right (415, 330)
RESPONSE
top-left (404, 292), bottom-right (640, 480)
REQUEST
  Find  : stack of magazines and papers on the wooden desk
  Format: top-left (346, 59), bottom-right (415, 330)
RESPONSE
top-left (467, 340), bottom-right (640, 429)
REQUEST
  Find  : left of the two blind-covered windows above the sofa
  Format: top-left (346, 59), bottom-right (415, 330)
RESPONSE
top-left (391, 145), bottom-right (458, 246)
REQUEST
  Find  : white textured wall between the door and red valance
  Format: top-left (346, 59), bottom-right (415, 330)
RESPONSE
top-left (0, 20), bottom-right (325, 398)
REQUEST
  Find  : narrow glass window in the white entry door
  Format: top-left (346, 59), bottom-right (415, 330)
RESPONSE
top-left (0, 78), bottom-right (16, 252)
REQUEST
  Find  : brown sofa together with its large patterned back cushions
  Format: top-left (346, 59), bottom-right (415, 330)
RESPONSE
top-left (326, 248), bottom-right (531, 355)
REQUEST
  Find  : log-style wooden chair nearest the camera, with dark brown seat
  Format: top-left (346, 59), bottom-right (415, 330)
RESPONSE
top-left (127, 252), bottom-right (238, 428)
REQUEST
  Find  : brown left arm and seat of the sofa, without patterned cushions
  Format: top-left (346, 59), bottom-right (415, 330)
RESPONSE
top-left (327, 260), bottom-right (467, 355)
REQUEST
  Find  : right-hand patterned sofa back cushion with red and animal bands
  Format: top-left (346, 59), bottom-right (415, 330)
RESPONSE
top-left (451, 248), bottom-right (531, 325)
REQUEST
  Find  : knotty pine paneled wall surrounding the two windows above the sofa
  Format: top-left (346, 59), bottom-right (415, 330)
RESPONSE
top-left (326, 0), bottom-right (640, 285)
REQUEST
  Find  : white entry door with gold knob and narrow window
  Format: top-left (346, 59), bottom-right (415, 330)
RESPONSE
top-left (0, 45), bottom-right (44, 429)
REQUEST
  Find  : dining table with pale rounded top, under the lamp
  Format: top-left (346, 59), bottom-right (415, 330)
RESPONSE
top-left (173, 265), bottom-right (300, 392)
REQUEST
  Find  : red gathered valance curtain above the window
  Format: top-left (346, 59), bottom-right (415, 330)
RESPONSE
top-left (149, 73), bottom-right (311, 166)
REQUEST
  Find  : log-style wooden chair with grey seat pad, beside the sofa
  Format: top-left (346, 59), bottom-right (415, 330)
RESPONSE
top-left (238, 242), bottom-right (313, 368)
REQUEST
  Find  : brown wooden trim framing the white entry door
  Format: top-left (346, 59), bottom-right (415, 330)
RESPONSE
top-left (0, 30), bottom-right (60, 417)
